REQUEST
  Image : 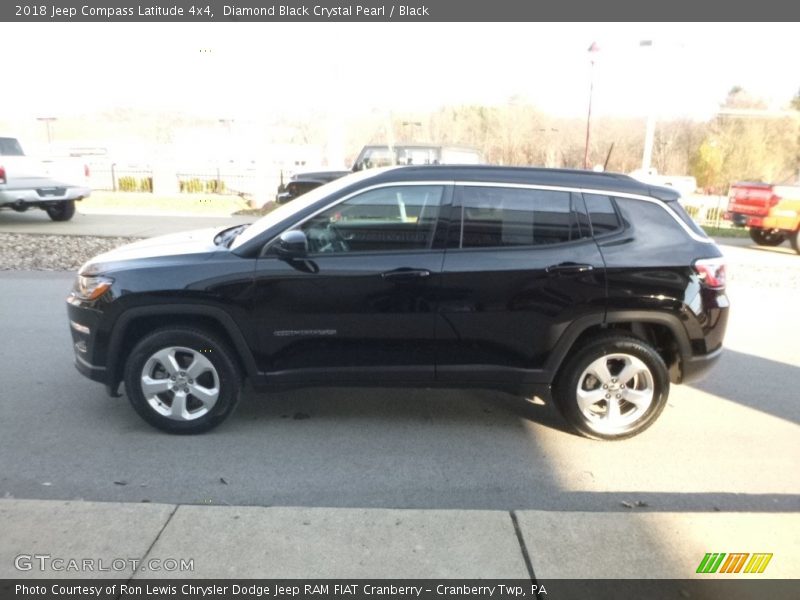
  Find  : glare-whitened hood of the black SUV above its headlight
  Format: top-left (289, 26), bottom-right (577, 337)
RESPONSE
top-left (80, 227), bottom-right (228, 275)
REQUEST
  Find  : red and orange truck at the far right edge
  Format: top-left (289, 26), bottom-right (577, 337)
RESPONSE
top-left (726, 181), bottom-right (800, 254)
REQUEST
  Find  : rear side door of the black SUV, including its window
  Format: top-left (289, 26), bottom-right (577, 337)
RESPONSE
top-left (437, 184), bottom-right (606, 383)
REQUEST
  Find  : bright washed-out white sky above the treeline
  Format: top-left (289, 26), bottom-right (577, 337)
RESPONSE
top-left (0, 23), bottom-right (800, 119)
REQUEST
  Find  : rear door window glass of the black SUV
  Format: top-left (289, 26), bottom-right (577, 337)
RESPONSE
top-left (450, 186), bottom-right (580, 248)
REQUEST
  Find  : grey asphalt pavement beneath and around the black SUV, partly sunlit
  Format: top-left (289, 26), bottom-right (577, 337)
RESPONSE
top-left (0, 232), bottom-right (800, 512)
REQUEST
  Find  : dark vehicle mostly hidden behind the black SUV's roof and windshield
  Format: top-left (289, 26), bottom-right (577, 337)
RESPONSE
top-left (275, 144), bottom-right (484, 204)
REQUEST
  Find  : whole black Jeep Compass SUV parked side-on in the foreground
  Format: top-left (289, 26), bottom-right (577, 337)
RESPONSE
top-left (68, 166), bottom-right (728, 439)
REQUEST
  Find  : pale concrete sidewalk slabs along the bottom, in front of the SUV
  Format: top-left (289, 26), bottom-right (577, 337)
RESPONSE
top-left (0, 499), bottom-right (800, 579)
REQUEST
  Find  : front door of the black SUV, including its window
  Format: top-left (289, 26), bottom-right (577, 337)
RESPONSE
top-left (255, 184), bottom-right (449, 384)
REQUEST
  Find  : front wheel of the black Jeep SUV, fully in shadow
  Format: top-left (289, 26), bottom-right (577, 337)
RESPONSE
top-left (125, 327), bottom-right (242, 434)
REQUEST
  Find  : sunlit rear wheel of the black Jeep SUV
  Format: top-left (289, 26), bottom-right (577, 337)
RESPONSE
top-left (554, 332), bottom-right (669, 440)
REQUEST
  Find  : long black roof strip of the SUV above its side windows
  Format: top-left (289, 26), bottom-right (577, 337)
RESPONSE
top-left (360, 165), bottom-right (677, 200)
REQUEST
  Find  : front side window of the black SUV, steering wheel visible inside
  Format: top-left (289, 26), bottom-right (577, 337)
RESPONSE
top-left (301, 185), bottom-right (444, 253)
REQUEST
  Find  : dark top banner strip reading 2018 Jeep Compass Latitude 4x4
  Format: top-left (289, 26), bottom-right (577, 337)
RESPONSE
top-left (0, 0), bottom-right (800, 23)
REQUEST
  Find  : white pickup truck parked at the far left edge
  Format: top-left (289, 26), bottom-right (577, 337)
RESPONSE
top-left (0, 137), bottom-right (91, 221)
